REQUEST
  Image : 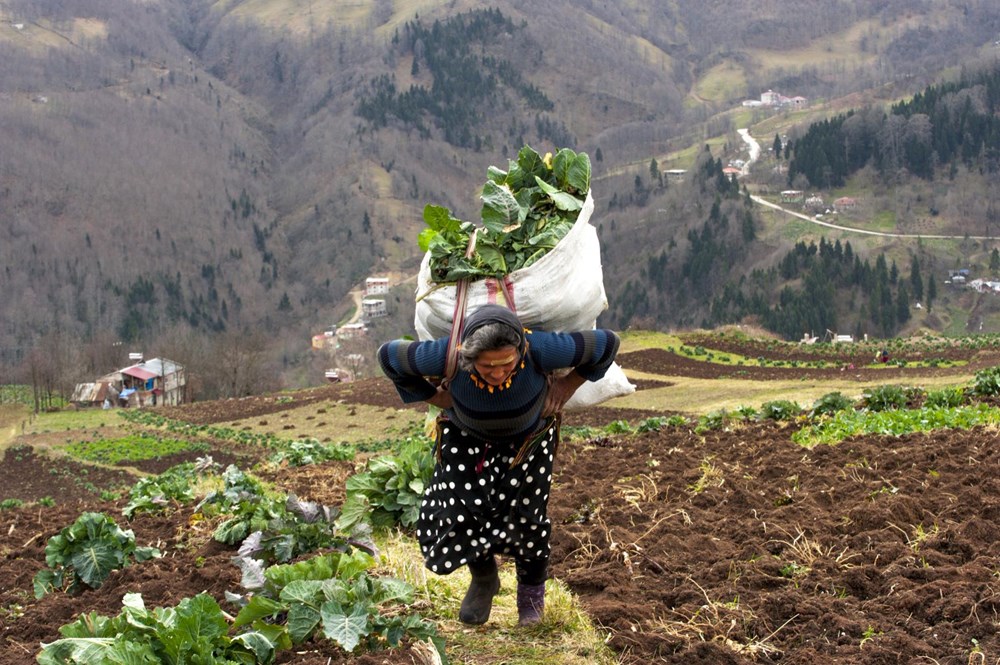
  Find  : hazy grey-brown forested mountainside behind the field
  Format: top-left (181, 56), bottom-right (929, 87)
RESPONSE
top-left (0, 0), bottom-right (1000, 395)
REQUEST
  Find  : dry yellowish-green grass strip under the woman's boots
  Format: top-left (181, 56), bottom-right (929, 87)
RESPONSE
top-left (378, 531), bottom-right (618, 665)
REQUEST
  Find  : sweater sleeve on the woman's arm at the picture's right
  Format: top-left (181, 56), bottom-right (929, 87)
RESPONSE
top-left (528, 328), bottom-right (620, 381)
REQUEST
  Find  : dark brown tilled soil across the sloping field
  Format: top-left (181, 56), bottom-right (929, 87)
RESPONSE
top-left (0, 347), bottom-right (1000, 665)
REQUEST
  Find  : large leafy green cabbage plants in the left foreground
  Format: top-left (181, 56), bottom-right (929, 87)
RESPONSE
top-left (35, 448), bottom-right (444, 665)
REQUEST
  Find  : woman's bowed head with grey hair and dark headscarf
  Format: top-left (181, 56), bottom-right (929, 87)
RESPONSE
top-left (458, 305), bottom-right (524, 385)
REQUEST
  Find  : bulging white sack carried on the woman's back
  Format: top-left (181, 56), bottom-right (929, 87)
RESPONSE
top-left (414, 192), bottom-right (635, 409)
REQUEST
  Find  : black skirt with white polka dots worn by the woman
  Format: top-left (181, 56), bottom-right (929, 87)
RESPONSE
top-left (417, 419), bottom-right (559, 575)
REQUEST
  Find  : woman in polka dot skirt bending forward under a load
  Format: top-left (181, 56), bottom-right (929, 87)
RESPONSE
top-left (378, 305), bottom-right (619, 626)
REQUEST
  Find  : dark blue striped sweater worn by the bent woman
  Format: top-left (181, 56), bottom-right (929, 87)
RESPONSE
top-left (378, 329), bottom-right (619, 443)
